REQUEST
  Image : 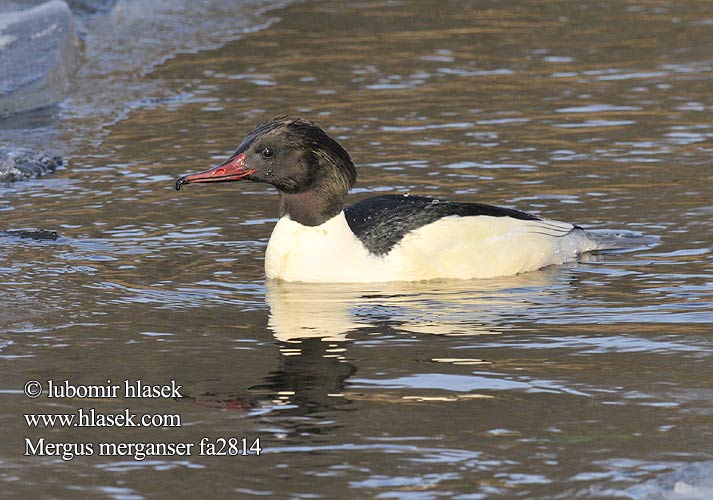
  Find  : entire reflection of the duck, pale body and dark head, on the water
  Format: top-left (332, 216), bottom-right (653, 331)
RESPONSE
top-left (184, 267), bottom-right (571, 435)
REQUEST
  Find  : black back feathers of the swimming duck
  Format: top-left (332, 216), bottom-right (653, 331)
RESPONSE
top-left (344, 194), bottom-right (542, 255)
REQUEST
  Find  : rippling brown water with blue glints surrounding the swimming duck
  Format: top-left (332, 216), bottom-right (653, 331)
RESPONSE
top-left (0, 1), bottom-right (713, 499)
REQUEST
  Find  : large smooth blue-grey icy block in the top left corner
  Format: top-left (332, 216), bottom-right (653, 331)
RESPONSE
top-left (0, 0), bottom-right (78, 117)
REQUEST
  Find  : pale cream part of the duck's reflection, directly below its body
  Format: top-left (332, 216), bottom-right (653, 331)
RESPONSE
top-left (266, 268), bottom-right (569, 344)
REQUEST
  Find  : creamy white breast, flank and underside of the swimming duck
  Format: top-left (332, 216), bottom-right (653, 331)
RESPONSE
top-left (265, 212), bottom-right (597, 282)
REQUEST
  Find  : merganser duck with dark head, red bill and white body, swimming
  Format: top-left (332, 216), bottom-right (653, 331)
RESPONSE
top-left (176, 116), bottom-right (603, 282)
